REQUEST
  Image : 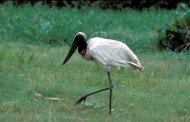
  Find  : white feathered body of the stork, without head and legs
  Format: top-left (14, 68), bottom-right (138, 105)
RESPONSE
top-left (81, 37), bottom-right (142, 70)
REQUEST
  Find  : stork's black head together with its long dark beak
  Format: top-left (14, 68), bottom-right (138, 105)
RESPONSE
top-left (63, 32), bottom-right (87, 64)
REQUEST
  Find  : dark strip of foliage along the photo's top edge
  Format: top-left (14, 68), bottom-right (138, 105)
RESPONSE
top-left (0, 0), bottom-right (190, 10)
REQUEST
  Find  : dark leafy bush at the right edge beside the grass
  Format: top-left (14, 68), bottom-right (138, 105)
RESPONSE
top-left (158, 10), bottom-right (190, 52)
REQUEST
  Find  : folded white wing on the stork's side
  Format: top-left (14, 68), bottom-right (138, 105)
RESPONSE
top-left (89, 38), bottom-right (142, 70)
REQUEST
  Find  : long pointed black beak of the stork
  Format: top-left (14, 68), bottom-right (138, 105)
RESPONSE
top-left (62, 40), bottom-right (78, 65)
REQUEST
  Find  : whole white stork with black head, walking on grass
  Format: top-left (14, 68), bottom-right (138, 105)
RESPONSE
top-left (63, 32), bottom-right (143, 114)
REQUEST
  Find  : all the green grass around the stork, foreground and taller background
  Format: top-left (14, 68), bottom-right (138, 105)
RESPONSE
top-left (0, 4), bottom-right (190, 122)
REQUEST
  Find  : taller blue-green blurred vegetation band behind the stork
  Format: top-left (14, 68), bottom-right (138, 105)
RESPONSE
top-left (0, 2), bottom-right (176, 50)
